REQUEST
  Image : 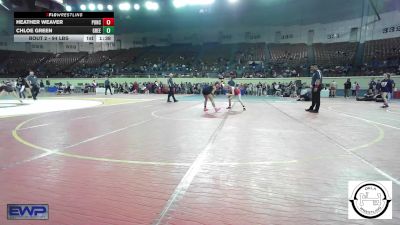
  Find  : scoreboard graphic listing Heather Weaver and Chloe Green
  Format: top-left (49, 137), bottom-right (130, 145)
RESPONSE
top-left (14, 12), bottom-right (114, 42)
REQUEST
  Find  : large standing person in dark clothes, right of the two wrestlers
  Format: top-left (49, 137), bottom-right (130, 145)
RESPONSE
top-left (306, 65), bottom-right (322, 113)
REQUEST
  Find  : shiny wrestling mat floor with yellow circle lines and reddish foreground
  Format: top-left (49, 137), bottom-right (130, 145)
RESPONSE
top-left (0, 95), bottom-right (400, 225)
